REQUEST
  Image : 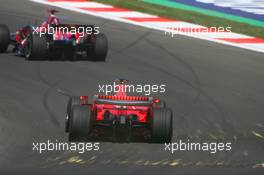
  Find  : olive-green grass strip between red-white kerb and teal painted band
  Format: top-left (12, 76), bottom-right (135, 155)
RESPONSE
top-left (92, 0), bottom-right (264, 38)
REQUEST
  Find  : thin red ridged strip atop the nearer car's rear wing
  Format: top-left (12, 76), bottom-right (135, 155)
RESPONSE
top-left (98, 95), bottom-right (149, 101)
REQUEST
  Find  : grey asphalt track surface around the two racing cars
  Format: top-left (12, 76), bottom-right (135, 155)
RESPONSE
top-left (0, 0), bottom-right (264, 175)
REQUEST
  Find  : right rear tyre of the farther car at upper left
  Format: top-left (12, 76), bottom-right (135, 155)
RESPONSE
top-left (87, 33), bottom-right (108, 61)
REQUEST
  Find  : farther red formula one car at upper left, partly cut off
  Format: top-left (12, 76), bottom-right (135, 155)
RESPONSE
top-left (0, 10), bottom-right (108, 61)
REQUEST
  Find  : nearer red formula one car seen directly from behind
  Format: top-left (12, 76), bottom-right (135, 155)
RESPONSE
top-left (66, 79), bottom-right (173, 143)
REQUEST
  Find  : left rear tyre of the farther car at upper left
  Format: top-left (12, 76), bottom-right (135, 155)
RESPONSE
top-left (24, 34), bottom-right (49, 60)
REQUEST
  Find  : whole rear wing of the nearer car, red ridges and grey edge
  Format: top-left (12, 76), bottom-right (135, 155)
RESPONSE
top-left (94, 95), bottom-right (153, 106)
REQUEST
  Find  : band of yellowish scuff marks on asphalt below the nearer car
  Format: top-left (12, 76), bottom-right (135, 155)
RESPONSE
top-left (39, 155), bottom-right (264, 169)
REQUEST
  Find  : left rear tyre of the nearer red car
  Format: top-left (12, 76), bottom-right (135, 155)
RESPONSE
top-left (69, 105), bottom-right (92, 142)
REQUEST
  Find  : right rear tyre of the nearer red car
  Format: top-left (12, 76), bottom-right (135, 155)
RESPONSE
top-left (151, 108), bottom-right (172, 143)
